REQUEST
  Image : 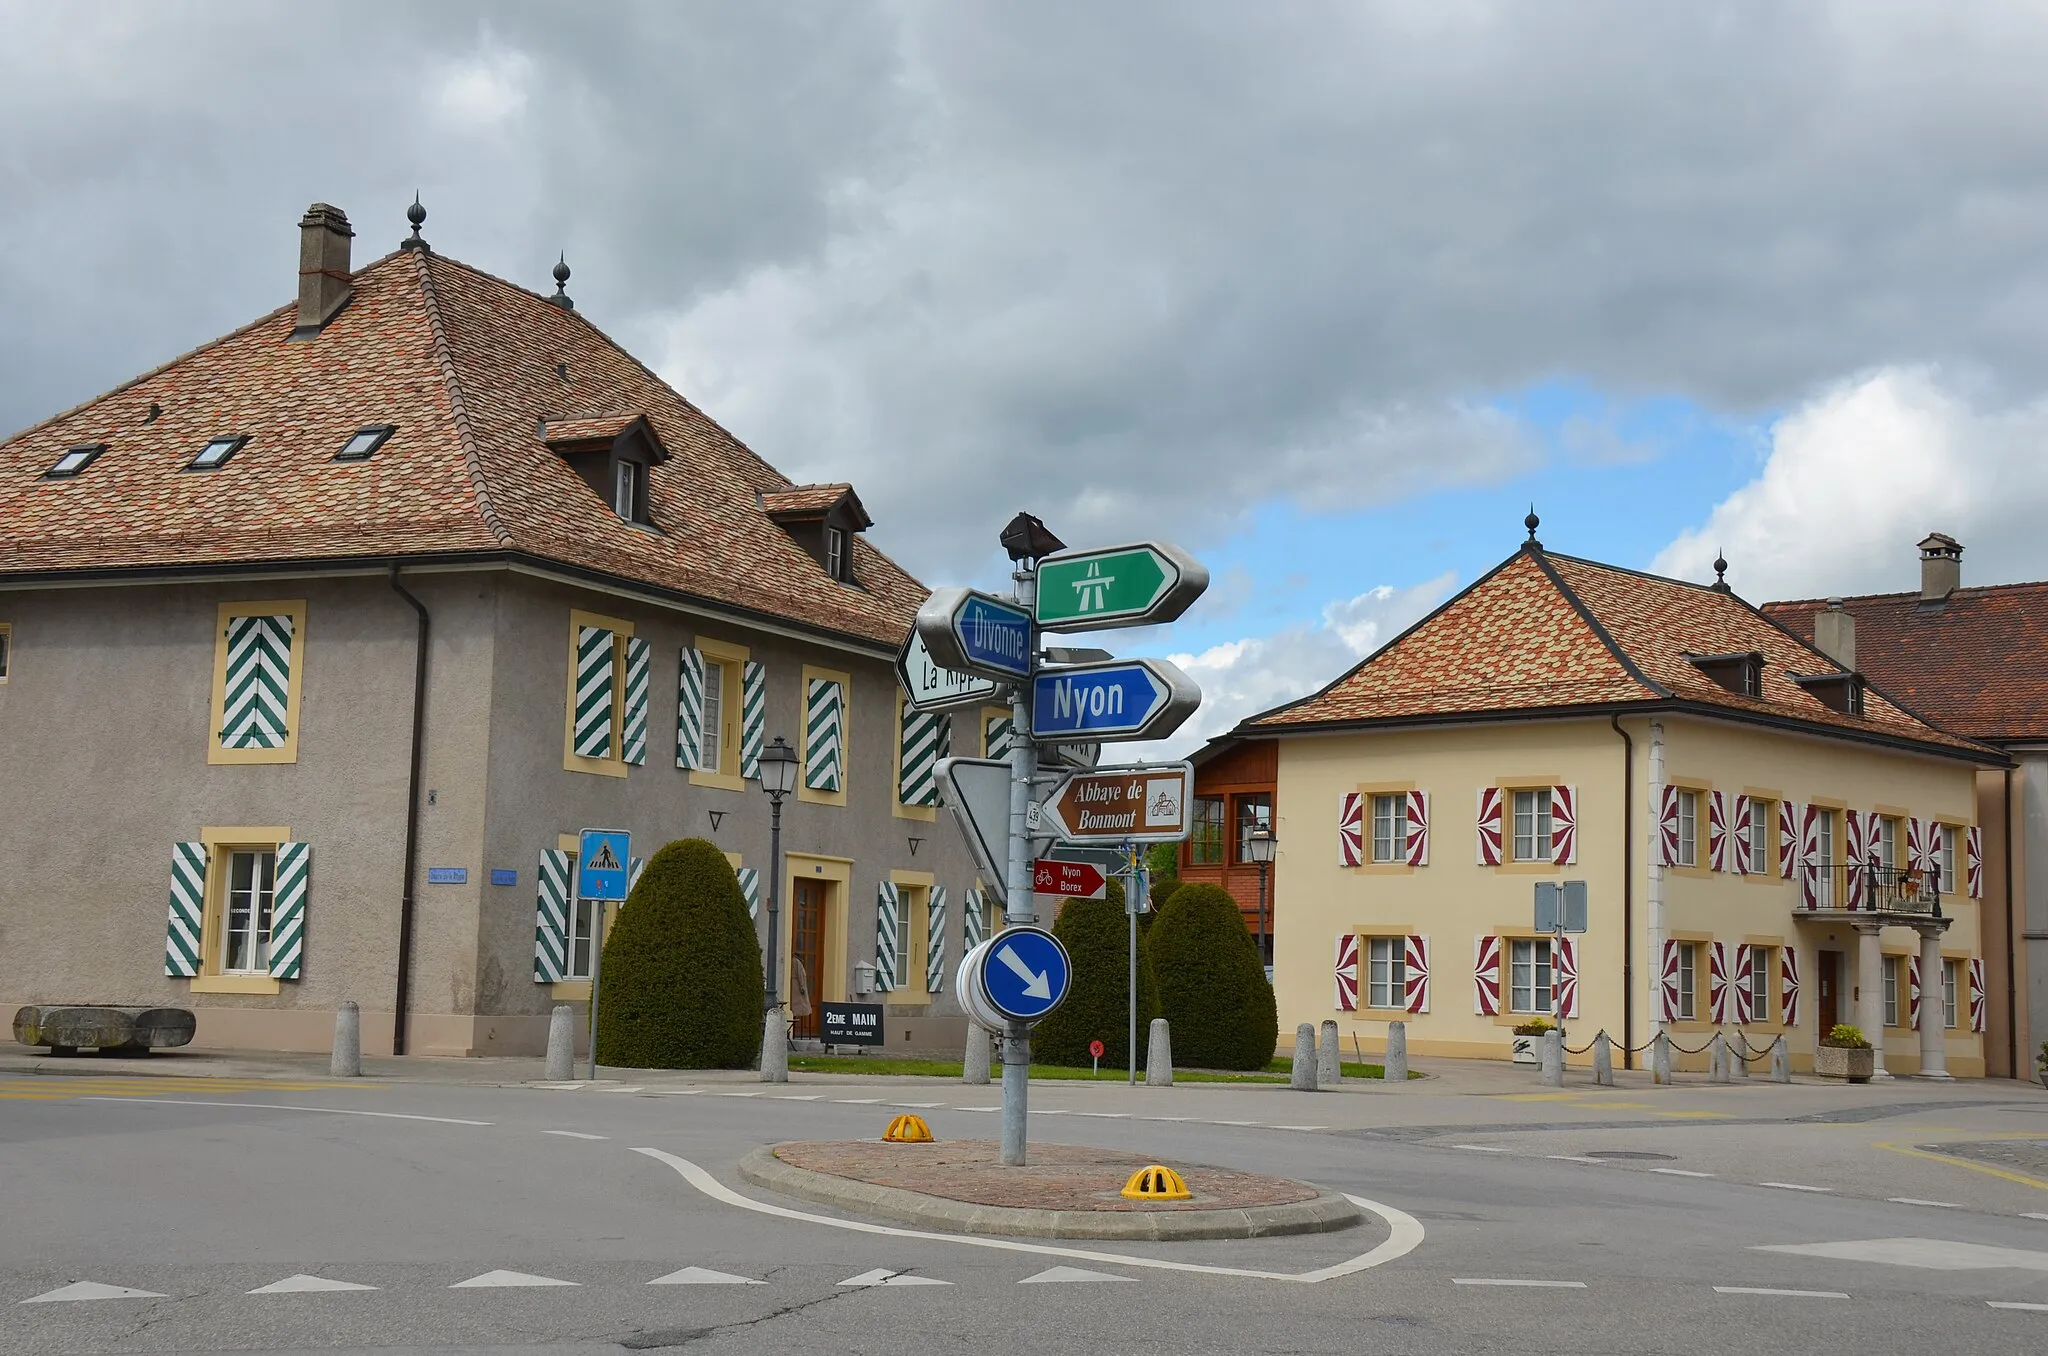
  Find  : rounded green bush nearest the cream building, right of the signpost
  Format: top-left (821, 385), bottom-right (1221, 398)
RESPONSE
top-left (1145, 885), bottom-right (1280, 1069)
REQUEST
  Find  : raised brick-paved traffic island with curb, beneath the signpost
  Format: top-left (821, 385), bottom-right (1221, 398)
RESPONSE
top-left (739, 1139), bottom-right (1364, 1241)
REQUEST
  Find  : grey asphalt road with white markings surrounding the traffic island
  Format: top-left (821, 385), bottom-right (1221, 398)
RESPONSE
top-left (0, 1077), bottom-right (2048, 1356)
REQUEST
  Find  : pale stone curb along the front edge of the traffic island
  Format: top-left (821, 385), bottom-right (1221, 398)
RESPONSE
top-left (739, 1145), bottom-right (1364, 1243)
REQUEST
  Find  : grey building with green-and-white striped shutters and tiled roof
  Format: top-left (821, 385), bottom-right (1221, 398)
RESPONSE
top-left (0, 205), bottom-right (1006, 1055)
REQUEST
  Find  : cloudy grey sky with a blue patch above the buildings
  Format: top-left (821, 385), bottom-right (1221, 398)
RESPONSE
top-left (0, 0), bottom-right (2048, 746)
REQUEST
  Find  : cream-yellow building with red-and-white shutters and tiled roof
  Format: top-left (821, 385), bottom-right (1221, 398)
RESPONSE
top-left (1237, 516), bottom-right (2005, 1075)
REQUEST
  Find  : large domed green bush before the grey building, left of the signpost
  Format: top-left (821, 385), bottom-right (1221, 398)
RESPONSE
top-left (598, 838), bottom-right (766, 1069)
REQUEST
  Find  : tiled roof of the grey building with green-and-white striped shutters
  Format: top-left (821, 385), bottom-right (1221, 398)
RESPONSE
top-left (0, 250), bottom-right (928, 645)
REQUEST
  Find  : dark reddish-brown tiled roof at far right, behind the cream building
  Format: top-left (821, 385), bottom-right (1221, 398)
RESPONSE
top-left (1763, 584), bottom-right (2048, 741)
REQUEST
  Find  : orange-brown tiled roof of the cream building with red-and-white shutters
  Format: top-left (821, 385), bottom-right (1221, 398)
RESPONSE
top-left (1239, 549), bottom-right (1991, 756)
